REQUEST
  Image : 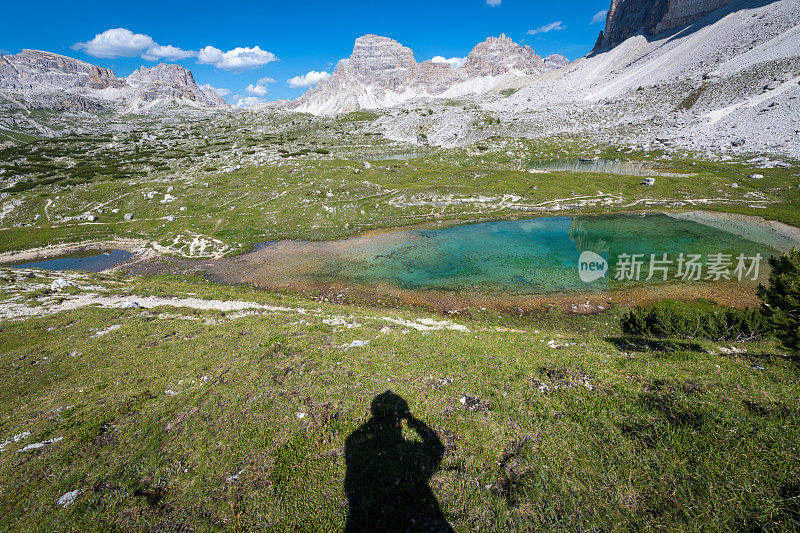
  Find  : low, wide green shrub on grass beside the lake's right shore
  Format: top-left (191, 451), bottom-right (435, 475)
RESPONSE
top-left (621, 300), bottom-right (770, 341)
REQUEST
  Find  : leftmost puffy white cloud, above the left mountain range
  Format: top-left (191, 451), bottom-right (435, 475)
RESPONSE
top-left (70, 28), bottom-right (196, 61)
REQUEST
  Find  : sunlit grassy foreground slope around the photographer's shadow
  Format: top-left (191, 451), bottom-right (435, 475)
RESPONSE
top-left (0, 274), bottom-right (800, 531)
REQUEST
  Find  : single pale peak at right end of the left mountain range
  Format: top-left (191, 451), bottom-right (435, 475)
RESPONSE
top-left (127, 63), bottom-right (225, 106)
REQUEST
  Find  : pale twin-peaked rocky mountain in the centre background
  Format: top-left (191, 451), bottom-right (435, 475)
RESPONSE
top-left (294, 35), bottom-right (569, 115)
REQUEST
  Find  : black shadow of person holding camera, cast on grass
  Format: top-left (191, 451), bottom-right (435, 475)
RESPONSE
top-left (344, 391), bottom-right (453, 532)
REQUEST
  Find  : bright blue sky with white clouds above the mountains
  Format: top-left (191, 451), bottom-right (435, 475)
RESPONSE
top-left (0, 0), bottom-right (609, 103)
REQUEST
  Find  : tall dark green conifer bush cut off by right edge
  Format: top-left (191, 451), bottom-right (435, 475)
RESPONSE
top-left (758, 248), bottom-right (800, 352)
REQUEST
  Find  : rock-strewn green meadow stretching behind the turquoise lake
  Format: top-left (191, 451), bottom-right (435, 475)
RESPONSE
top-left (0, 125), bottom-right (800, 255)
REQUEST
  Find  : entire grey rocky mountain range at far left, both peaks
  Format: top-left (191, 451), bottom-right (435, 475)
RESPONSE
top-left (0, 50), bottom-right (226, 111)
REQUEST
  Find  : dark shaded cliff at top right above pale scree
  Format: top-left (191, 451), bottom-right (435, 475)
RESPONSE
top-left (595, 0), bottom-right (731, 51)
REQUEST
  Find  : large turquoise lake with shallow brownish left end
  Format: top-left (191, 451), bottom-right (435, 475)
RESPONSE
top-left (224, 214), bottom-right (791, 296)
